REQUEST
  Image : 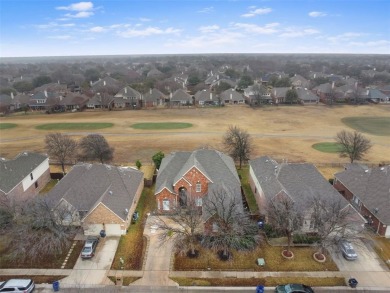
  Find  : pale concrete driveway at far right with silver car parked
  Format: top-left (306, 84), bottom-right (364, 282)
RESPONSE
top-left (331, 239), bottom-right (388, 272)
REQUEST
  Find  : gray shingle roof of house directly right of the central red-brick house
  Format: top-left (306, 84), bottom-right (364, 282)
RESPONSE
top-left (250, 156), bottom-right (348, 210)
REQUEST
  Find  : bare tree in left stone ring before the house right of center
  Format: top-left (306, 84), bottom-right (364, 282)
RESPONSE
top-left (267, 193), bottom-right (303, 251)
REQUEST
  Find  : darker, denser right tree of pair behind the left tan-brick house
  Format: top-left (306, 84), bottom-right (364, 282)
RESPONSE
top-left (79, 134), bottom-right (114, 164)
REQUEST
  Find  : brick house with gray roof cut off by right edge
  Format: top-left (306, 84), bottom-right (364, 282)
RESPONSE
top-left (333, 164), bottom-right (390, 238)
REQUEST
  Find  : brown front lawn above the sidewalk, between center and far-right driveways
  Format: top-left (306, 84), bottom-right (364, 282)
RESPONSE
top-left (174, 243), bottom-right (338, 272)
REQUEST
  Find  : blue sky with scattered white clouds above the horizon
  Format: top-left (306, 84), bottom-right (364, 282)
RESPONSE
top-left (0, 0), bottom-right (390, 57)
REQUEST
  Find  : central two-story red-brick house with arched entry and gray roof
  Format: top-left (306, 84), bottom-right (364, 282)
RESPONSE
top-left (155, 149), bottom-right (243, 232)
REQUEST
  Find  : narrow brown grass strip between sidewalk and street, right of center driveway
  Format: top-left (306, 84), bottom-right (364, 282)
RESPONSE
top-left (171, 277), bottom-right (345, 287)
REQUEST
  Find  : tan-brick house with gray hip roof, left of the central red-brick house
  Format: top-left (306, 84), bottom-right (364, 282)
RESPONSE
top-left (47, 163), bottom-right (144, 236)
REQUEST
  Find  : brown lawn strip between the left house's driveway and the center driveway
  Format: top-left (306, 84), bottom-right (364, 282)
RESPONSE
top-left (111, 185), bottom-right (156, 270)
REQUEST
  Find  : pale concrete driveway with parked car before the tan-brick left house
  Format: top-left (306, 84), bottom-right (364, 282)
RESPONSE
top-left (61, 237), bottom-right (119, 286)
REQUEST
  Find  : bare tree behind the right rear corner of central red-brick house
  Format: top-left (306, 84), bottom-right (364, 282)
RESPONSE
top-left (222, 125), bottom-right (252, 169)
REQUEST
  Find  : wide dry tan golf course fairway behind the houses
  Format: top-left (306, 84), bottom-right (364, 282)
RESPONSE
top-left (0, 105), bottom-right (390, 164)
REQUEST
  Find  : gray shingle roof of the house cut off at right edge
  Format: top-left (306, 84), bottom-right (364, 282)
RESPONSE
top-left (335, 164), bottom-right (390, 225)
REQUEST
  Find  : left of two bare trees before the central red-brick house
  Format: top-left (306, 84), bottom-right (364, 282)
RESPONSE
top-left (154, 199), bottom-right (203, 256)
